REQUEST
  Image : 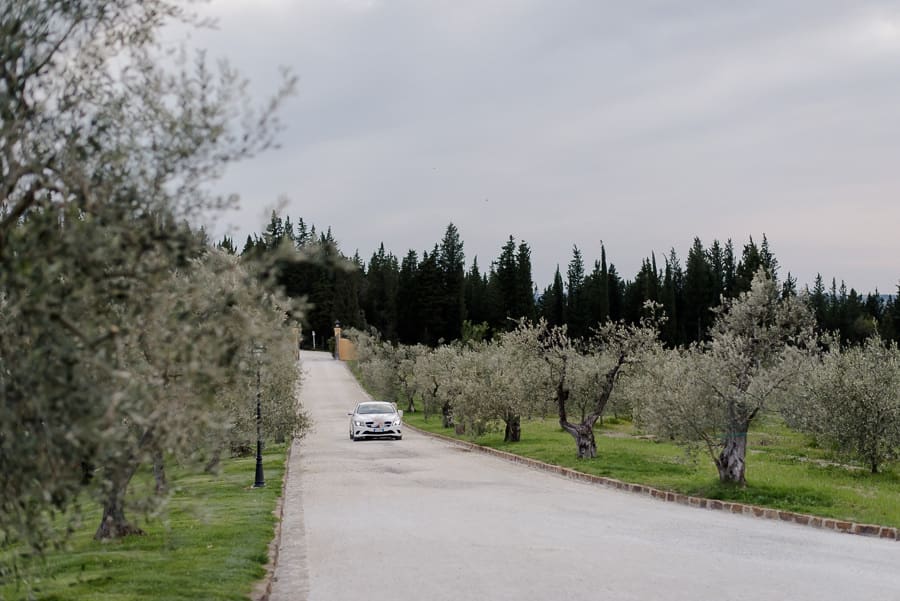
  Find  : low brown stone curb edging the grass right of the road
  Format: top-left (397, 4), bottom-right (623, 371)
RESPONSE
top-left (404, 423), bottom-right (900, 540)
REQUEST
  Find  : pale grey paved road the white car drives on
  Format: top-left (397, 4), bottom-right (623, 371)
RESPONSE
top-left (272, 353), bottom-right (900, 601)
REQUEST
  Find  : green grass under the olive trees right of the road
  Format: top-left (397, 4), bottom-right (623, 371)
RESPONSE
top-left (404, 412), bottom-right (900, 527)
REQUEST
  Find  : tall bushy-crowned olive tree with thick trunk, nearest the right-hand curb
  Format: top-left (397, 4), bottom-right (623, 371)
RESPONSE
top-left (636, 270), bottom-right (815, 485)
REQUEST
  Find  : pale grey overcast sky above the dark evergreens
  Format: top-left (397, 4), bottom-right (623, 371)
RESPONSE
top-left (181, 0), bottom-right (900, 293)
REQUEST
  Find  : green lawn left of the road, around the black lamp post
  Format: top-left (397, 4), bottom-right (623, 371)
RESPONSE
top-left (0, 445), bottom-right (286, 601)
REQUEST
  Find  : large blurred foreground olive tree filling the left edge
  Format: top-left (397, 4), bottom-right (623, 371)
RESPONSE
top-left (0, 0), bottom-right (293, 550)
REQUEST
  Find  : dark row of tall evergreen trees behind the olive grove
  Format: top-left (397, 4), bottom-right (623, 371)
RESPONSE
top-left (227, 212), bottom-right (900, 347)
